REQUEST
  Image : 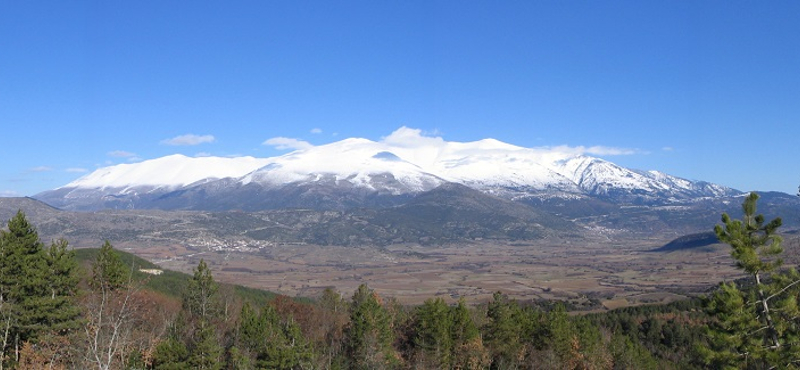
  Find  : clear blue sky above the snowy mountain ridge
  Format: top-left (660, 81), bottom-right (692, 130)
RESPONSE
top-left (0, 0), bottom-right (800, 196)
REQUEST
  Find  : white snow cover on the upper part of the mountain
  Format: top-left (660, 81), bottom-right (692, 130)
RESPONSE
top-left (54, 127), bottom-right (727, 199)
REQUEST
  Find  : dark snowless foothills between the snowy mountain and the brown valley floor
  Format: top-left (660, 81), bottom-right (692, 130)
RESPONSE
top-left (6, 188), bottom-right (800, 251)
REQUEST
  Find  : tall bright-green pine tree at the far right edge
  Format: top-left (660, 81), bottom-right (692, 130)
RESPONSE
top-left (699, 193), bottom-right (800, 368)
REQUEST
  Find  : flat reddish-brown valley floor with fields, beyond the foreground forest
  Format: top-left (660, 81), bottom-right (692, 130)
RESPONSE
top-left (123, 239), bottom-right (741, 310)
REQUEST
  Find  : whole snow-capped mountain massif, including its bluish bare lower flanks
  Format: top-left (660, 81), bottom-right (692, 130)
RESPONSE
top-left (36, 127), bottom-right (737, 210)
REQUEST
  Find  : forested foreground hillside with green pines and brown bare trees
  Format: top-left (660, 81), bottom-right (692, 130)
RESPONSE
top-left (0, 196), bottom-right (800, 370)
